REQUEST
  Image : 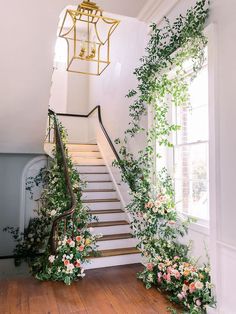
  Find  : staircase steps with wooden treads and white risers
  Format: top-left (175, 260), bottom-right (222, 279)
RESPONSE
top-left (67, 144), bottom-right (141, 269)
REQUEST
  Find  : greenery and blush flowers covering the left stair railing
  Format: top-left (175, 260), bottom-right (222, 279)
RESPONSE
top-left (5, 120), bottom-right (96, 285)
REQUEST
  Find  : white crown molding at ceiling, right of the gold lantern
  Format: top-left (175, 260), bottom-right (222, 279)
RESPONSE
top-left (137, 0), bottom-right (179, 24)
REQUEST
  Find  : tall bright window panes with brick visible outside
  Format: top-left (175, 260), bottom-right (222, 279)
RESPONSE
top-left (173, 52), bottom-right (209, 220)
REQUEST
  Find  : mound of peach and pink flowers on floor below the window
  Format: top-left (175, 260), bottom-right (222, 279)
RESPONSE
top-left (139, 255), bottom-right (215, 314)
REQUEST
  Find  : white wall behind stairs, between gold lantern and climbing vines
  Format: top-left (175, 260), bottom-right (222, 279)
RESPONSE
top-left (89, 16), bottom-right (147, 200)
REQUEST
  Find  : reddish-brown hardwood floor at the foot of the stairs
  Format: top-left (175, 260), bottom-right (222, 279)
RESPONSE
top-left (0, 264), bottom-right (179, 314)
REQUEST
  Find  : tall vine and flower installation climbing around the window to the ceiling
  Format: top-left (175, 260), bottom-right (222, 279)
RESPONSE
top-left (114, 0), bottom-right (215, 314)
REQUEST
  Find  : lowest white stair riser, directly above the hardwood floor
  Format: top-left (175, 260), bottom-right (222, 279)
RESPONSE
top-left (84, 254), bottom-right (141, 269)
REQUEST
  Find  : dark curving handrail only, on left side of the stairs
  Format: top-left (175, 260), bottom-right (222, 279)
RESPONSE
top-left (48, 109), bottom-right (77, 254)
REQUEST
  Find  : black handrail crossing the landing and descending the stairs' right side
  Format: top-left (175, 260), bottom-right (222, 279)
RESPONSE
top-left (54, 106), bottom-right (121, 162)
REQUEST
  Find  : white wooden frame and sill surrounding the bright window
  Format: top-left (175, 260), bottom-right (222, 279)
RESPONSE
top-left (152, 23), bottom-right (218, 231)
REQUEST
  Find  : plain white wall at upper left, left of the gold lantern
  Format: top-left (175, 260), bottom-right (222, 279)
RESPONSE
top-left (0, 0), bottom-right (80, 153)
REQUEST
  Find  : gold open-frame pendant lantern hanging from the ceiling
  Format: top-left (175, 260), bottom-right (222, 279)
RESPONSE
top-left (59, 0), bottom-right (120, 75)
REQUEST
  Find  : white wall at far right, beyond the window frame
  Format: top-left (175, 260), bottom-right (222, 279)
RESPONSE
top-left (159, 0), bottom-right (236, 314)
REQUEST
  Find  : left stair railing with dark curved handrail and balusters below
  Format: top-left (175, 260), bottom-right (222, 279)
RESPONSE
top-left (48, 109), bottom-right (77, 255)
